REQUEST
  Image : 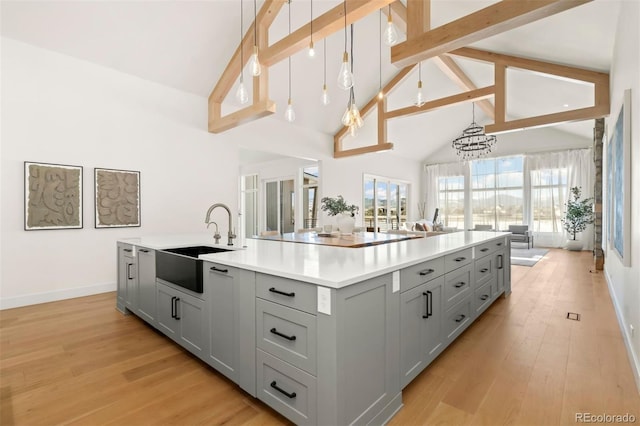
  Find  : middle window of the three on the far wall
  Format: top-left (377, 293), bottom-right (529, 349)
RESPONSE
top-left (471, 157), bottom-right (524, 230)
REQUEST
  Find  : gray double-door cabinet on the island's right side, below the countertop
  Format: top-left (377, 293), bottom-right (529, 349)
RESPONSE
top-left (400, 276), bottom-right (444, 388)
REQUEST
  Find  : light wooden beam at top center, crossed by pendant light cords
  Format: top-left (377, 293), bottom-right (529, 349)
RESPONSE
top-left (261, 0), bottom-right (395, 67)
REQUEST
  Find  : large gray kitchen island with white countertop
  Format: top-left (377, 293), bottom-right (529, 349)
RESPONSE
top-left (118, 231), bottom-right (510, 425)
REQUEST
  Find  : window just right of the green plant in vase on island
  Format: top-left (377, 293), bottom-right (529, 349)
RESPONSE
top-left (363, 175), bottom-right (409, 232)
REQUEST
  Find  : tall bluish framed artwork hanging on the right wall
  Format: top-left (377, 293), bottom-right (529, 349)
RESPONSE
top-left (609, 89), bottom-right (631, 266)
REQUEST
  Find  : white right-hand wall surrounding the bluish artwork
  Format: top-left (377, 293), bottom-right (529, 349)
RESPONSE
top-left (603, 1), bottom-right (640, 389)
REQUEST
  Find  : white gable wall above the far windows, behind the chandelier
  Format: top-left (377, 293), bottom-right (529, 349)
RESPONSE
top-left (425, 127), bottom-right (593, 164)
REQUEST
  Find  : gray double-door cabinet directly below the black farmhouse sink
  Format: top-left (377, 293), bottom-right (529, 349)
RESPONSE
top-left (156, 281), bottom-right (207, 359)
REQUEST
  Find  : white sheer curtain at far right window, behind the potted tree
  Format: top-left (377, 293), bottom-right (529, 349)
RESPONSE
top-left (524, 149), bottom-right (595, 250)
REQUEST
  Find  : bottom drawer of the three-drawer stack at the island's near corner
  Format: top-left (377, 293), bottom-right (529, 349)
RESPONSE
top-left (257, 349), bottom-right (317, 425)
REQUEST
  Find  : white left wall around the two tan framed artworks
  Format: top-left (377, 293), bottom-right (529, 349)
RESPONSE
top-left (0, 38), bottom-right (238, 308)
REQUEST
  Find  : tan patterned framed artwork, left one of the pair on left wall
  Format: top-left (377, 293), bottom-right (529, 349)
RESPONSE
top-left (24, 161), bottom-right (83, 231)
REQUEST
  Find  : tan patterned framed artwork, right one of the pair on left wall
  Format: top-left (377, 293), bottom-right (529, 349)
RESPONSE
top-left (94, 167), bottom-right (141, 229)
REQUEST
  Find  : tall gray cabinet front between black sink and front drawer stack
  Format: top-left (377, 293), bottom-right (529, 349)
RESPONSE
top-left (203, 262), bottom-right (256, 396)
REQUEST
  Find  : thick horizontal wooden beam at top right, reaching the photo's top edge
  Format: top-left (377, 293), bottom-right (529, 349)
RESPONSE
top-left (391, 0), bottom-right (593, 66)
